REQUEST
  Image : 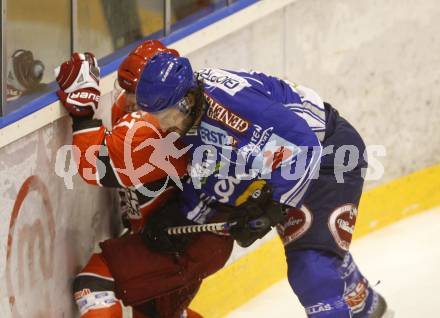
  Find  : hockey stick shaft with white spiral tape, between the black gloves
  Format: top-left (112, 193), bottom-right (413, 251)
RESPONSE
top-left (166, 217), bottom-right (270, 235)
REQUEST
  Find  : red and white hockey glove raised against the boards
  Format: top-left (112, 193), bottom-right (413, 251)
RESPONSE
top-left (55, 53), bottom-right (101, 117)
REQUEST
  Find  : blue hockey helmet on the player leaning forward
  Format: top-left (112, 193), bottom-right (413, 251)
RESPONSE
top-left (136, 53), bottom-right (195, 113)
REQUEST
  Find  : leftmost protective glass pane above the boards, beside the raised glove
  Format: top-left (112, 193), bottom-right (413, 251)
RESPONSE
top-left (0, 0), bottom-right (72, 115)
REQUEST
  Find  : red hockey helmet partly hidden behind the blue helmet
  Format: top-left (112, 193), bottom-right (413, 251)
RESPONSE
top-left (118, 40), bottom-right (180, 94)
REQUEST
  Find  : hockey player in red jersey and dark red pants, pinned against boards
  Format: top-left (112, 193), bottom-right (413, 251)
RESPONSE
top-left (57, 41), bottom-right (232, 318)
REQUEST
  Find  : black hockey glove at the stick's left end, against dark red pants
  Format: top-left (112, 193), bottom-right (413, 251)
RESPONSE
top-left (141, 199), bottom-right (192, 254)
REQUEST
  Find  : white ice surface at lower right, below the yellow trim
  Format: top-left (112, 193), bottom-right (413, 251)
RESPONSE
top-left (227, 207), bottom-right (440, 318)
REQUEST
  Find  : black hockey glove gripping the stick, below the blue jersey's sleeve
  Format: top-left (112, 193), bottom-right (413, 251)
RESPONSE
top-left (228, 184), bottom-right (286, 247)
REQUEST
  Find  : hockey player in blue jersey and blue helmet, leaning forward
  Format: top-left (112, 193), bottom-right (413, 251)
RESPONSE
top-left (136, 54), bottom-right (387, 318)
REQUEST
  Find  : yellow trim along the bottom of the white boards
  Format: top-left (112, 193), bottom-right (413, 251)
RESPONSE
top-left (190, 164), bottom-right (440, 318)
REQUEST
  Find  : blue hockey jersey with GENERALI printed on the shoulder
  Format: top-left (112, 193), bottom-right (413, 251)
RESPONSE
top-left (183, 69), bottom-right (326, 223)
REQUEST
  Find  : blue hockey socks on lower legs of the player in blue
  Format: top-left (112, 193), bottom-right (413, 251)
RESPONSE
top-left (286, 250), bottom-right (377, 318)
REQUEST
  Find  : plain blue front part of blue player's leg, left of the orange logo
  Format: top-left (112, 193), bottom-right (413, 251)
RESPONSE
top-left (287, 250), bottom-right (350, 318)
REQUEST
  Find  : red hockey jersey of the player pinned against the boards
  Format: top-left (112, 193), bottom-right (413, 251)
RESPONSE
top-left (72, 94), bottom-right (187, 232)
